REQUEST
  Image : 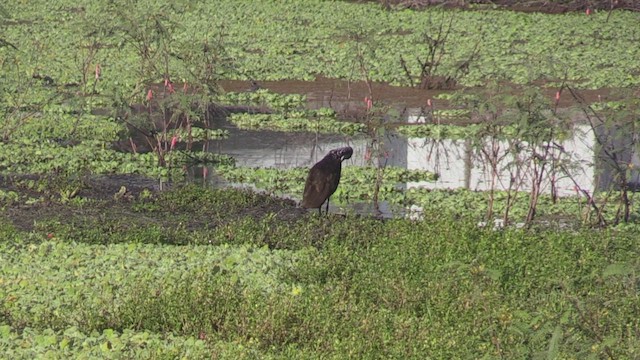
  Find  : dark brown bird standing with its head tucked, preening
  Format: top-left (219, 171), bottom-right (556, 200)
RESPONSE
top-left (301, 146), bottom-right (353, 214)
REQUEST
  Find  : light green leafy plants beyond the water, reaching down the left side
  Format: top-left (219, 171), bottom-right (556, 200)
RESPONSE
top-left (0, 0), bottom-right (639, 178)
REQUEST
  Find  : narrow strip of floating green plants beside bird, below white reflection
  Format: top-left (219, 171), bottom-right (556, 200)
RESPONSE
top-left (216, 166), bottom-right (640, 226)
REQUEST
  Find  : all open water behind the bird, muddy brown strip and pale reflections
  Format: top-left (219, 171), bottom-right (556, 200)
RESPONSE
top-left (182, 77), bottom-right (640, 217)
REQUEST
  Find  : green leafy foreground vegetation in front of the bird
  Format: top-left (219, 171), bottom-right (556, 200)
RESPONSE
top-left (0, 187), bottom-right (640, 358)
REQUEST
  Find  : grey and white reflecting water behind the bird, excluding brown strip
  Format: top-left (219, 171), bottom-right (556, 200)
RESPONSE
top-left (195, 108), bottom-right (640, 216)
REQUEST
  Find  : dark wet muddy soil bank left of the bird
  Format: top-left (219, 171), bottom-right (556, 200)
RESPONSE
top-left (0, 175), bottom-right (308, 235)
